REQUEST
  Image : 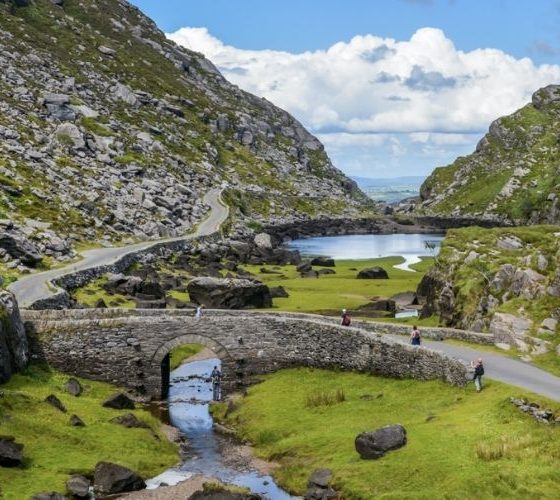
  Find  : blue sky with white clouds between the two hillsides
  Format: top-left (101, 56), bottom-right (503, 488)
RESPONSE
top-left (132, 0), bottom-right (560, 177)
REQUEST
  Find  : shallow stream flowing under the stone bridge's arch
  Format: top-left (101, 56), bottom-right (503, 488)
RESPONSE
top-left (146, 358), bottom-right (299, 500)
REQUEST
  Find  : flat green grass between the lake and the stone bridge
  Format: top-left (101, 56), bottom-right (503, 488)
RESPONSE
top-left (243, 257), bottom-right (433, 314)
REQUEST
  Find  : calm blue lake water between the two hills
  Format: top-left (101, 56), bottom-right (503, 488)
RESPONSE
top-left (288, 234), bottom-right (444, 271)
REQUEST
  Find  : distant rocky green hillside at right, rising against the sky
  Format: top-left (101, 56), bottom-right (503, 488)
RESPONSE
top-left (418, 85), bottom-right (560, 225)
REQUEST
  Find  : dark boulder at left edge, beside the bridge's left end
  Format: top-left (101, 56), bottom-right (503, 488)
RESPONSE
top-left (0, 290), bottom-right (29, 383)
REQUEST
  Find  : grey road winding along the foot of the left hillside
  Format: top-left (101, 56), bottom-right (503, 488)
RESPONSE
top-left (9, 189), bottom-right (229, 308)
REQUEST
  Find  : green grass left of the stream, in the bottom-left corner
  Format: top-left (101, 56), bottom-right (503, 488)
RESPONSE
top-left (0, 365), bottom-right (179, 500)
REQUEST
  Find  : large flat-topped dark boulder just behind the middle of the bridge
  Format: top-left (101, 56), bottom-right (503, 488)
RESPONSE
top-left (187, 277), bottom-right (272, 309)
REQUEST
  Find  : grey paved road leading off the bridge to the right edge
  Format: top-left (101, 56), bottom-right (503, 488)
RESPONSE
top-left (387, 335), bottom-right (560, 401)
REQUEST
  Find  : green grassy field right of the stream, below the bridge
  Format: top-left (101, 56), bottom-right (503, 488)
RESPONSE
top-left (214, 369), bottom-right (560, 499)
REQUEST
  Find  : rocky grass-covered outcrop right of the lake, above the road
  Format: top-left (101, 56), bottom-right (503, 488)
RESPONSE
top-left (418, 226), bottom-right (560, 352)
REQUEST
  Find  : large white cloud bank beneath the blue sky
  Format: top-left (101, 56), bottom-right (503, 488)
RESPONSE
top-left (168, 27), bottom-right (560, 176)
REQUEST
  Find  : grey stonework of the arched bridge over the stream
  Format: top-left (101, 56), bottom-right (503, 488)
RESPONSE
top-left (22, 309), bottom-right (467, 399)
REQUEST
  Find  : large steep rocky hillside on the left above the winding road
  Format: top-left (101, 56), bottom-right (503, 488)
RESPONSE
top-left (0, 0), bottom-right (367, 271)
